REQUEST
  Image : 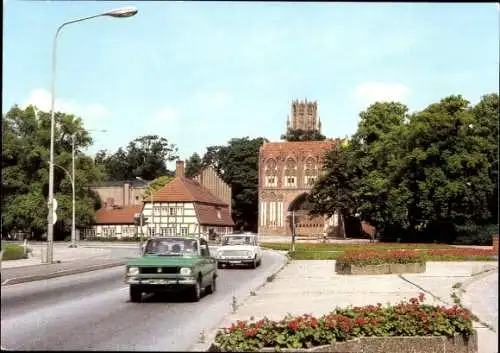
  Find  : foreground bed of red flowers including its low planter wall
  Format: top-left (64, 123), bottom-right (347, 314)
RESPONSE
top-left (210, 293), bottom-right (477, 353)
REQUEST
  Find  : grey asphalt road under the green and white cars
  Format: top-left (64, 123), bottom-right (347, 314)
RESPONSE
top-left (1, 251), bottom-right (284, 351)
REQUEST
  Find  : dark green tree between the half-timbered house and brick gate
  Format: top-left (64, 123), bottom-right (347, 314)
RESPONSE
top-left (203, 137), bottom-right (268, 231)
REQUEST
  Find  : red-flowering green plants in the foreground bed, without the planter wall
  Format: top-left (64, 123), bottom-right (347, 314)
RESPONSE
top-left (215, 293), bottom-right (474, 351)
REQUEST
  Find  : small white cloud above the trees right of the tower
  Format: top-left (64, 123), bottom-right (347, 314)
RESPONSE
top-left (354, 82), bottom-right (410, 105)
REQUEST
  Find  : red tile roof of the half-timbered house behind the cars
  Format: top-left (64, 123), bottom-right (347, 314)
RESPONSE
top-left (148, 177), bottom-right (228, 206)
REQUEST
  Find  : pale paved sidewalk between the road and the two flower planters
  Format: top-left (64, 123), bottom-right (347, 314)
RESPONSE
top-left (193, 260), bottom-right (498, 353)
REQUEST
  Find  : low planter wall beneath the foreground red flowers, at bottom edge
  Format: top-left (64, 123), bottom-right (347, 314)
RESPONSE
top-left (208, 333), bottom-right (478, 353)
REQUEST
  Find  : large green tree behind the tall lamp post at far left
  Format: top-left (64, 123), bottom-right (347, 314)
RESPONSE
top-left (2, 106), bottom-right (105, 239)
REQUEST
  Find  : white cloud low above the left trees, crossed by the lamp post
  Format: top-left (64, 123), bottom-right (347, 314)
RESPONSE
top-left (22, 88), bottom-right (109, 119)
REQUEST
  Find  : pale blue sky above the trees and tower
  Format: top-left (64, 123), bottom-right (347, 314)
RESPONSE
top-left (2, 0), bottom-right (499, 166)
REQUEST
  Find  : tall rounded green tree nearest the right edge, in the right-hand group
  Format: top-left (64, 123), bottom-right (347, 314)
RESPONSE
top-left (401, 95), bottom-right (498, 241)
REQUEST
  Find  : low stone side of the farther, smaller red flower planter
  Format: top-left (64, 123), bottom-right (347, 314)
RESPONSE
top-left (335, 261), bottom-right (426, 275)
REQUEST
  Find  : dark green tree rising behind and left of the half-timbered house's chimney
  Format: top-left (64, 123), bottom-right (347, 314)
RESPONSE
top-left (96, 135), bottom-right (178, 180)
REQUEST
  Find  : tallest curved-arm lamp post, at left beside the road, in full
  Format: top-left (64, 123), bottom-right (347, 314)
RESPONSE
top-left (47, 7), bottom-right (138, 263)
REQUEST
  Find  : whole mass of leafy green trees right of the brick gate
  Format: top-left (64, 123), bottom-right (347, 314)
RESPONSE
top-left (309, 94), bottom-right (499, 241)
